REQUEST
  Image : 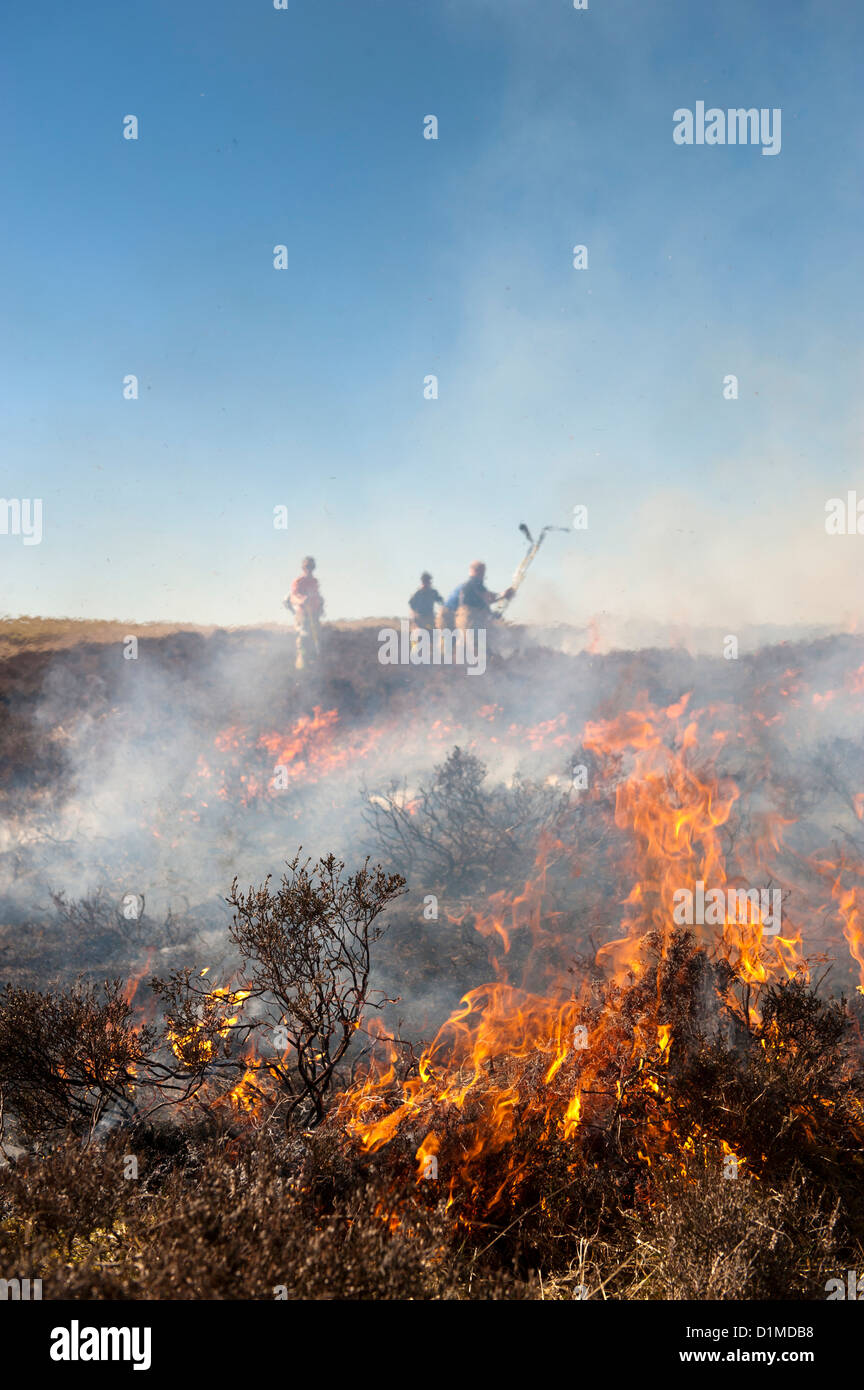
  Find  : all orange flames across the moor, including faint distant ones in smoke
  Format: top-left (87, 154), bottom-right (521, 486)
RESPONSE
top-left (167, 670), bottom-right (864, 1219)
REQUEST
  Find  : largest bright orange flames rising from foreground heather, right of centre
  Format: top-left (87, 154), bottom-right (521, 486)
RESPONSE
top-left (330, 696), bottom-right (833, 1207)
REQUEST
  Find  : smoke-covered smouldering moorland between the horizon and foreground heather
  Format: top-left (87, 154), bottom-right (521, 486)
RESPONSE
top-left (0, 624), bottom-right (864, 1027)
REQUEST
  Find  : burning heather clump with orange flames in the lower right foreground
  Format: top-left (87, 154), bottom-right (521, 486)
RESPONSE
top-left (322, 933), bottom-right (864, 1297)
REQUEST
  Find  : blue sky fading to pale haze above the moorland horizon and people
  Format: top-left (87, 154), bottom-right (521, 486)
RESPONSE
top-left (0, 0), bottom-right (864, 624)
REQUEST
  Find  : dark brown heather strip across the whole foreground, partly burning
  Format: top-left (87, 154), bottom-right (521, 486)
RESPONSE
top-left (0, 922), bottom-right (864, 1300)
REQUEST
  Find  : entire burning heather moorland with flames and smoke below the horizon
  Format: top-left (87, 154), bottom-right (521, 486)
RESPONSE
top-left (0, 627), bottom-right (864, 1300)
